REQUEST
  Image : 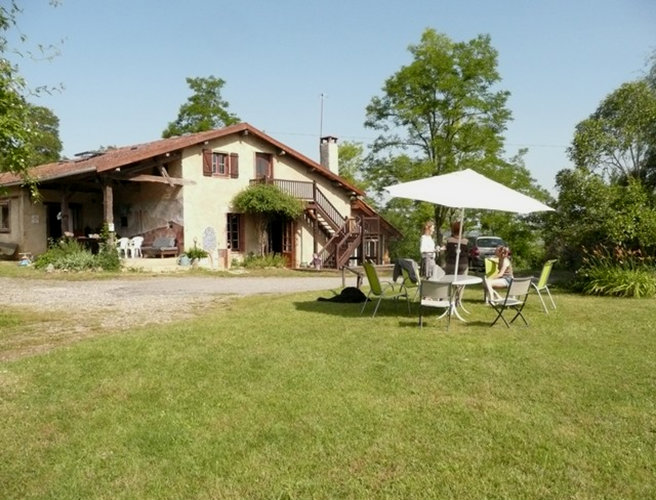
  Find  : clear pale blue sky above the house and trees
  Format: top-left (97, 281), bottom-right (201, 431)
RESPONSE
top-left (10, 0), bottom-right (656, 192)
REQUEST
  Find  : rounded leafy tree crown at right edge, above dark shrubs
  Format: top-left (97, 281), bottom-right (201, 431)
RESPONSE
top-left (569, 79), bottom-right (656, 188)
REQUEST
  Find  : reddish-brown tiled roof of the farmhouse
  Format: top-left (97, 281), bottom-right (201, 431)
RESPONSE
top-left (0, 123), bottom-right (364, 195)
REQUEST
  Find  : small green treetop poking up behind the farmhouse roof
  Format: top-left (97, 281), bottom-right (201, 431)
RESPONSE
top-left (162, 76), bottom-right (239, 138)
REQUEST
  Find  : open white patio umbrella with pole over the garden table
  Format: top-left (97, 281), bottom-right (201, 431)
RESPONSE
top-left (385, 169), bottom-right (553, 274)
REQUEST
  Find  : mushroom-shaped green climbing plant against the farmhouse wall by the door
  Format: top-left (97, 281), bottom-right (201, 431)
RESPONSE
top-left (232, 184), bottom-right (303, 256)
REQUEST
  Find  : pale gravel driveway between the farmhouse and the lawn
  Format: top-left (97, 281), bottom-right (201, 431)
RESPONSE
top-left (0, 276), bottom-right (351, 360)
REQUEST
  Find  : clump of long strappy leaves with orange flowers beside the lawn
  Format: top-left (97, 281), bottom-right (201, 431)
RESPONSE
top-left (574, 246), bottom-right (656, 297)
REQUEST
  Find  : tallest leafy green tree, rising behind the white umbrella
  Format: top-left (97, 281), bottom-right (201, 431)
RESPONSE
top-left (365, 29), bottom-right (511, 240)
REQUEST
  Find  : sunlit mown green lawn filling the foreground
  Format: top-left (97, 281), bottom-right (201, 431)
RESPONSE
top-left (0, 282), bottom-right (656, 499)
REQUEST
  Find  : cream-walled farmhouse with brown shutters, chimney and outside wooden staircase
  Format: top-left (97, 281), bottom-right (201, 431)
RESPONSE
top-left (0, 123), bottom-right (400, 268)
